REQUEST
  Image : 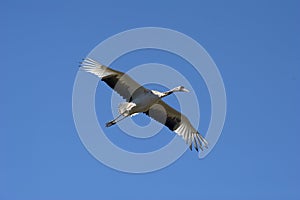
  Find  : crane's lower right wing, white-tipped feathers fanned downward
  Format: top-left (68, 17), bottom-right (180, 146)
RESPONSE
top-left (145, 100), bottom-right (208, 151)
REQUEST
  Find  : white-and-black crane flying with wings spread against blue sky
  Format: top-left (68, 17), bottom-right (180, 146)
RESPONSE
top-left (80, 58), bottom-right (208, 152)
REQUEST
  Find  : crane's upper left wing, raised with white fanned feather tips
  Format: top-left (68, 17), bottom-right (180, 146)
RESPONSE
top-left (81, 58), bottom-right (147, 101)
